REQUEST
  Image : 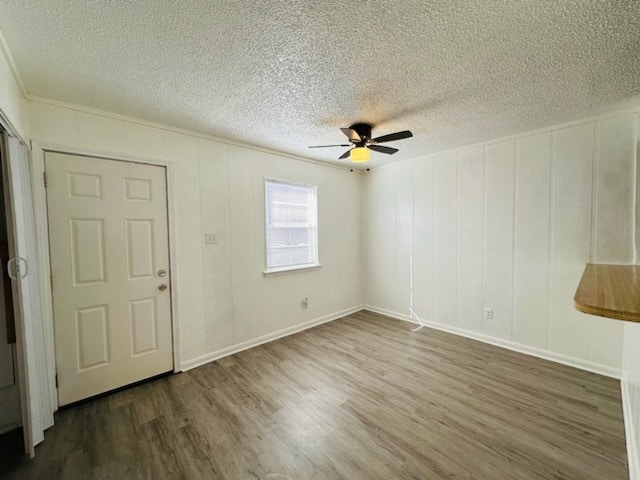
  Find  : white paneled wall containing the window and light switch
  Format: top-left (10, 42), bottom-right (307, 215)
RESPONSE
top-left (29, 101), bottom-right (362, 368)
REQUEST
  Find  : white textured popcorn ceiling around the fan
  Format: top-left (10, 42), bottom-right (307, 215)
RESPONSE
top-left (0, 0), bottom-right (640, 166)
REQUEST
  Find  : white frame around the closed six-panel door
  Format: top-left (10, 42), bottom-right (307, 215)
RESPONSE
top-left (31, 140), bottom-right (181, 412)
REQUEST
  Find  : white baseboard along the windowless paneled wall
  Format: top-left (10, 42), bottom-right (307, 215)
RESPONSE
top-left (364, 305), bottom-right (622, 380)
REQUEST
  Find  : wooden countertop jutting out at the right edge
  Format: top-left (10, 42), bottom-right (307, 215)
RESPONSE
top-left (573, 263), bottom-right (640, 322)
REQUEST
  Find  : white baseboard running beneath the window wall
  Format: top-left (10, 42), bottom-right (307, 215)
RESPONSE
top-left (180, 305), bottom-right (364, 372)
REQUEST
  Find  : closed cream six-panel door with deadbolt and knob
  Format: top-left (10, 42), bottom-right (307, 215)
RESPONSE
top-left (45, 153), bottom-right (173, 405)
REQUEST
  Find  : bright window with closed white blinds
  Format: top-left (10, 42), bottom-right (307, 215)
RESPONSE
top-left (265, 180), bottom-right (318, 273)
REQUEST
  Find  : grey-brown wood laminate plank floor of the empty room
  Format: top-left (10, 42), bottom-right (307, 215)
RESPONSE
top-left (0, 312), bottom-right (628, 480)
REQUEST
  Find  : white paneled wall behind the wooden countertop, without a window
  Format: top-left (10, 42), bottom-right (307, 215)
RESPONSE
top-left (362, 112), bottom-right (637, 376)
